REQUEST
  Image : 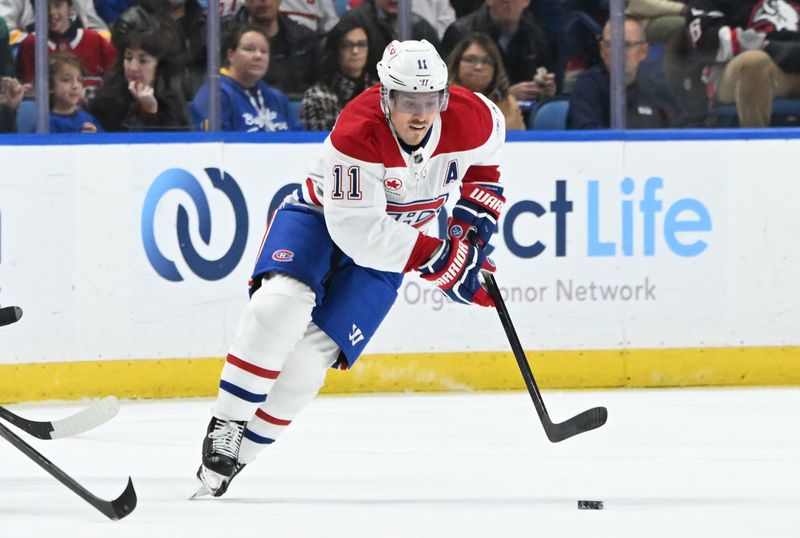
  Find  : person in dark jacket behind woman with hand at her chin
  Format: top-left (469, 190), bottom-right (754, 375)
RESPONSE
top-left (134, 0), bottom-right (208, 99)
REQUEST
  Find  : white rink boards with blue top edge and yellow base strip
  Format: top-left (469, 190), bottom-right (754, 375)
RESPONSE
top-left (0, 131), bottom-right (800, 401)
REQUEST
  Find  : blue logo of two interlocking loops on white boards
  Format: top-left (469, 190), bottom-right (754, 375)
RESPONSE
top-left (142, 168), bottom-right (248, 282)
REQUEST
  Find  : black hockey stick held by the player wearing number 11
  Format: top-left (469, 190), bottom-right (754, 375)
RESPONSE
top-left (483, 272), bottom-right (608, 443)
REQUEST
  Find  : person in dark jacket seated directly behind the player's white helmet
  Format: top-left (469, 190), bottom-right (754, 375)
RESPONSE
top-left (342, 0), bottom-right (439, 78)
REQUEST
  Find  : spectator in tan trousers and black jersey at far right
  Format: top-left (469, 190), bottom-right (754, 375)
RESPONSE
top-left (688, 0), bottom-right (800, 127)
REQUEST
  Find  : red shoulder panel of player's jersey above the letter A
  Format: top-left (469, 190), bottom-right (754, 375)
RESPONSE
top-left (434, 86), bottom-right (494, 155)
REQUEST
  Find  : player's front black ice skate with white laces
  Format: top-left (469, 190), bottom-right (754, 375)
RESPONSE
top-left (191, 417), bottom-right (245, 498)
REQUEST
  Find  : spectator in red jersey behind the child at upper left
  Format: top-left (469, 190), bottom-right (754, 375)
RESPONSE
top-left (17, 0), bottom-right (117, 96)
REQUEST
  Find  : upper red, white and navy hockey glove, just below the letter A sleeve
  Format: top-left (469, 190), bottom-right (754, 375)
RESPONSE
top-left (447, 184), bottom-right (506, 247)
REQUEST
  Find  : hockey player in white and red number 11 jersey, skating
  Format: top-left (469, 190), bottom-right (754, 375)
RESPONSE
top-left (196, 41), bottom-right (505, 496)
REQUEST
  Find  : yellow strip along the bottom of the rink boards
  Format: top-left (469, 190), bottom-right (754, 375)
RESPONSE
top-left (0, 346), bottom-right (800, 403)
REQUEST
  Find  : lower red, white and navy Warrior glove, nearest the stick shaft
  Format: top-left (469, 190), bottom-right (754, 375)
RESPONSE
top-left (419, 239), bottom-right (495, 306)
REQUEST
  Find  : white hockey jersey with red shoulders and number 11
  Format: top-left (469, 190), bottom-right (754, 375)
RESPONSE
top-left (288, 84), bottom-right (505, 272)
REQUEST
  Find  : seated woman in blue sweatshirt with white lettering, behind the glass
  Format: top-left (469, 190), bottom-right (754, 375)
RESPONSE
top-left (191, 24), bottom-right (303, 133)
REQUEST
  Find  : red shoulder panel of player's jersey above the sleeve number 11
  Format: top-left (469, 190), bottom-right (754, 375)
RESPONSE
top-left (331, 84), bottom-right (405, 167)
